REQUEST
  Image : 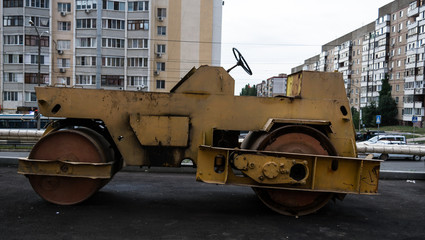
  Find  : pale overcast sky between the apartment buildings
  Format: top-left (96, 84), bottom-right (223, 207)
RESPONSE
top-left (221, 0), bottom-right (392, 95)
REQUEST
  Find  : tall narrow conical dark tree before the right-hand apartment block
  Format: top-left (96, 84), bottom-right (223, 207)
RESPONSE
top-left (377, 77), bottom-right (398, 125)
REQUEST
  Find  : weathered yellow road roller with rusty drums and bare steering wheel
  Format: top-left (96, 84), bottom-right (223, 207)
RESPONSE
top-left (18, 49), bottom-right (380, 216)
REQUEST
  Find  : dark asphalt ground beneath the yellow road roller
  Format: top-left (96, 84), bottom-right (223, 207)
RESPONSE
top-left (0, 165), bottom-right (425, 240)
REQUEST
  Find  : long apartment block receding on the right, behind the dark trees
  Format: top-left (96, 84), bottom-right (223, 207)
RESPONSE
top-left (292, 0), bottom-right (425, 125)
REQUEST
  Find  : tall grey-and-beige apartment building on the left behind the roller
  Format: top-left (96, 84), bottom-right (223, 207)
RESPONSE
top-left (0, 0), bottom-right (222, 113)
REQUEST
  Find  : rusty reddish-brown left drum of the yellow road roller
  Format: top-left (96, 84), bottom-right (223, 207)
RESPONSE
top-left (27, 128), bottom-right (114, 205)
